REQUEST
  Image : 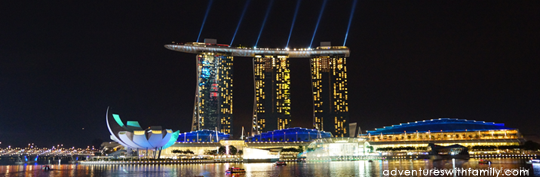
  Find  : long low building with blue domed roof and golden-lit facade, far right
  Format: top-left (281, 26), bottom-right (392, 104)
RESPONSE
top-left (360, 118), bottom-right (524, 154)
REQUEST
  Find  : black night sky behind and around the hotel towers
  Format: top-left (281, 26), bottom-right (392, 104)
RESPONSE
top-left (0, 0), bottom-right (540, 147)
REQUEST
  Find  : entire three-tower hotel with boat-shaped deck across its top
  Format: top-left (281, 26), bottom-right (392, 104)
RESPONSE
top-left (165, 39), bottom-right (349, 137)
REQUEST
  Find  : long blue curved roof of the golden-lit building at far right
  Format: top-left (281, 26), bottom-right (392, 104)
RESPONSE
top-left (367, 118), bottom-right (514, 135)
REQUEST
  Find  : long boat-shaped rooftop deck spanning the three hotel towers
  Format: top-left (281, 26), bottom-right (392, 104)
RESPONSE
top-left (165, 42), bottom-right (349, 58)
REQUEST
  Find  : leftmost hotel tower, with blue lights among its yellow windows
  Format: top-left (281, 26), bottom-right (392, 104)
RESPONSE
top-left (191, 49), bottom-right (233, 134)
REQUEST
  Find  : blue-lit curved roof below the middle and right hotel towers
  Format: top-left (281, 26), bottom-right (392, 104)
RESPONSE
top-left (248, 127), bottom-right (332, 142)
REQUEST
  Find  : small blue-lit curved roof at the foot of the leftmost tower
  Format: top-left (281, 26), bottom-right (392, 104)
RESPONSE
top-left (177, 129), bottom-right (231, 142)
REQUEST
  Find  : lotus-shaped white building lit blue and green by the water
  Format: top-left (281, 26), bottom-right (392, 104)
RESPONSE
top-left (105, 109), bottom-right (180, 150)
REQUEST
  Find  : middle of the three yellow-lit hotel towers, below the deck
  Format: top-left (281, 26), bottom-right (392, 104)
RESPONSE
top-left (253, 55), bottom-right (291, 134)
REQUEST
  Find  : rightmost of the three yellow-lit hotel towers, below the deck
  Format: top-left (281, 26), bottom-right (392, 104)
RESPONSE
top-left (311, 51), bottom-right (349, 137)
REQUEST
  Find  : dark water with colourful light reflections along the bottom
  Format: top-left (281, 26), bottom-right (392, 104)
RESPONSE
top-left (0, 159), bottom-right (540, 177)
